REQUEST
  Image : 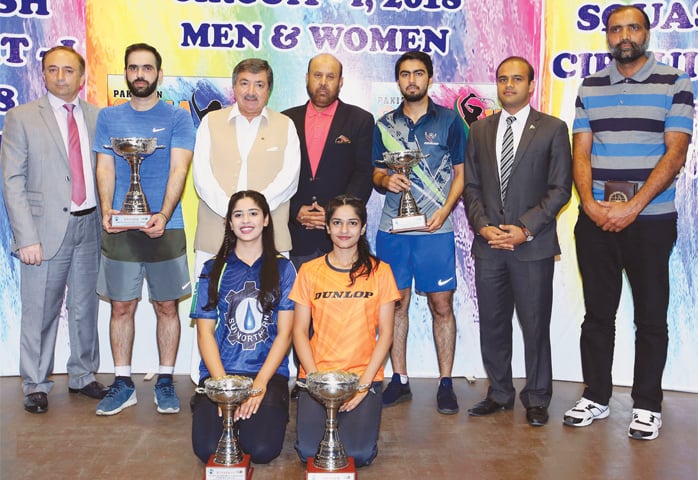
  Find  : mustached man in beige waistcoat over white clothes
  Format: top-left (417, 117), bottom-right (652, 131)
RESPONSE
top-left (192, 58), bottom-right (300, 381)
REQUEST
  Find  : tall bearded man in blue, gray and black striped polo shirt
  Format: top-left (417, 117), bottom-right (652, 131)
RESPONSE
top-left (563, 6), bottom-right (694, 440)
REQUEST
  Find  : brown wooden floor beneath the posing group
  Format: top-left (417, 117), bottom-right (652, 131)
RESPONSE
top-left (0, 375), bottom-right (698, 480)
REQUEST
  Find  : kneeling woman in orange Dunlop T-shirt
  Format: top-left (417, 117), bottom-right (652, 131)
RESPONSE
top-left (290, 196), bottom-right (400, 467)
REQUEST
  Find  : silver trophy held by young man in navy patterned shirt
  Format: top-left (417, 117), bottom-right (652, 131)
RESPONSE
top-left (379, 150), bottom-right (427, 233)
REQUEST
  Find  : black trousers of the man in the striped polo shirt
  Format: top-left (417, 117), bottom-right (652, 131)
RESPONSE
top-left (575, 211), bottom-right (676, 412)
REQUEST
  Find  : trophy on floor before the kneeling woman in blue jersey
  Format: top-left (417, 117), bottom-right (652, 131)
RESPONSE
top-left (204, 375), bottom-right (255, 480)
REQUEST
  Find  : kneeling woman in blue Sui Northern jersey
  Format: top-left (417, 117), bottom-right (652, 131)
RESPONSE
top-left (190, 190), bottom-right (296, 463)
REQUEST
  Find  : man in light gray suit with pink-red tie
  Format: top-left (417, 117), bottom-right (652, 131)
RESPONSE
top-left (0, 46), bottom-right (106, 413)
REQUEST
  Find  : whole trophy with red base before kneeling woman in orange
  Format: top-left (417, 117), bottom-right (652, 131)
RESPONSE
top-left (305, 370), bottom-right (359, 480)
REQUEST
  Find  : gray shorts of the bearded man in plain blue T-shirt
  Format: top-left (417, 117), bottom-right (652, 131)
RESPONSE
top-left (97, 255), bottom-right (191, 302)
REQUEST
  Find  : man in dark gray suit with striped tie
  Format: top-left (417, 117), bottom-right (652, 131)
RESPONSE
top-left (464, 57), bottom-right (572, 426)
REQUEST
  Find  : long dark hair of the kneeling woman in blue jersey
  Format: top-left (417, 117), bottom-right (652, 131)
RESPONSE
top-left (204, 190), bottom-right (281, 314)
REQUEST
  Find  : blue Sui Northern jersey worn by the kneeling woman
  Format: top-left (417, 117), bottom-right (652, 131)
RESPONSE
top-left (189, 252), bottom-right (296, 378)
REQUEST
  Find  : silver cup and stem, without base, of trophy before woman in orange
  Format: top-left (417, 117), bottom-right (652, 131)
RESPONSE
top-left (306, 370), bottom-right (359, 470)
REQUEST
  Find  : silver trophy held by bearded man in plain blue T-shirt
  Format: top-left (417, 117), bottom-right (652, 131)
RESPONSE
top-left (104, 137), bottom-right (165, 229)
